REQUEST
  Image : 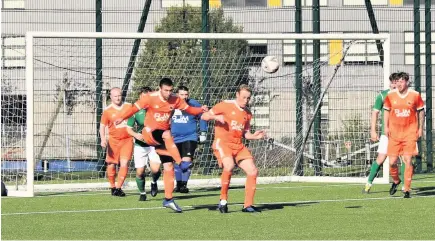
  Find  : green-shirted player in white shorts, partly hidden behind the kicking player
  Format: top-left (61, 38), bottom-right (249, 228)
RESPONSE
top-left (127, 87), bottom-right (161, 201)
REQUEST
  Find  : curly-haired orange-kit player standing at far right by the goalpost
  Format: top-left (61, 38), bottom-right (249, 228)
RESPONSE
top-left (384, 72), bottom-right (424, 198)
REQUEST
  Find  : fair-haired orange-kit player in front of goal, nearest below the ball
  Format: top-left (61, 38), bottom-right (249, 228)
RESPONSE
top-left (202, 85), bottom-right (265, 213)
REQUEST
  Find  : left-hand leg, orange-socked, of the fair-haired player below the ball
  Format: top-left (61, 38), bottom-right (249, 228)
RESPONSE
top-left (218, 157), bottom-right (236, 213)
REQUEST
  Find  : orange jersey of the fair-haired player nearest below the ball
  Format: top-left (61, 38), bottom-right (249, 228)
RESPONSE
top-left (210, 100), bottom-right (252, 144)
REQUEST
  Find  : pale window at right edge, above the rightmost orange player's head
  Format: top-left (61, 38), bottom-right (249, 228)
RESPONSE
top-left (405, 32), bottom-right (435, 64)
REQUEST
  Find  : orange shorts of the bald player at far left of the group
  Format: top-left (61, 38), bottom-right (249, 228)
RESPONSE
top-left (106, 138), bottom-right (134, 164)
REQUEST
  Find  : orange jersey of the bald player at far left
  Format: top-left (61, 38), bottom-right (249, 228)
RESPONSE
top-left (101, 103), bottom-right (132, 140)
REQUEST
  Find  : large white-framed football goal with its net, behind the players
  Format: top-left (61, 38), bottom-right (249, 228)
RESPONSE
top-left (1, 32), bottom-right (390, 196)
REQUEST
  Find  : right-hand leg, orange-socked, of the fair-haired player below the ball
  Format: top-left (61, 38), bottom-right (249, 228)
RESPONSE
top-left (239, 159), bottom-right (259, 213)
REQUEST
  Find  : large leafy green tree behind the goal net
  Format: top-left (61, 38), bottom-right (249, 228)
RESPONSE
top-left (130, 5), bottom-right (250, 104)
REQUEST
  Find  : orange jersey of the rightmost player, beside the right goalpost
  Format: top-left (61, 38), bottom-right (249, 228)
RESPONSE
top-left (384, 90), bottom-right (424, 141)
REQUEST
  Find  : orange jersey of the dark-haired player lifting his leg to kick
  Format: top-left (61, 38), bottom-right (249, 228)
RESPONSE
top-left (134, 91), bottom-right (189, 130)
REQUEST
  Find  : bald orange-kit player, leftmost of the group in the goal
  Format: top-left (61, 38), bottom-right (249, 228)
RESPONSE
top-left (100, 88), bottom-right (133, 197)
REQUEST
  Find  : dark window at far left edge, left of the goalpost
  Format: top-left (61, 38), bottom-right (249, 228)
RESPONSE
top-left (1, 95), bottom-right (27, 126)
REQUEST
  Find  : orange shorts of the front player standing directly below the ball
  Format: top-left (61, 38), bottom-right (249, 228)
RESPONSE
top-left (213, 139), bottom-right (254, 167)
